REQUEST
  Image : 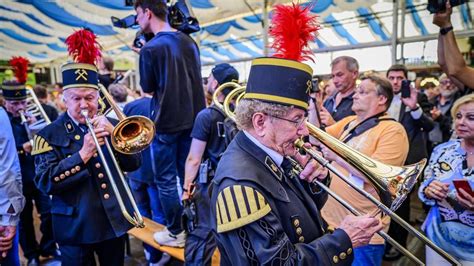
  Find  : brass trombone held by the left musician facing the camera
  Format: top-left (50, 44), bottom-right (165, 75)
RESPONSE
top-left (81, 84), bottom-right (155, 228)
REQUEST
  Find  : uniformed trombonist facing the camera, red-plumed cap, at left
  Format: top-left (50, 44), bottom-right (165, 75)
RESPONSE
top-left (34, 30), bottom-right (140, 265)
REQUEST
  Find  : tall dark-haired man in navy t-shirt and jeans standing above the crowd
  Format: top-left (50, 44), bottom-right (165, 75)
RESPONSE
top-left (134, 0), bottom-right (205, 247)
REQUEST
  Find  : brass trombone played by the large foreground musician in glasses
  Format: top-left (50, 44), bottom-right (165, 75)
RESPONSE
top-left (223, 89), bottom-right (460, 265)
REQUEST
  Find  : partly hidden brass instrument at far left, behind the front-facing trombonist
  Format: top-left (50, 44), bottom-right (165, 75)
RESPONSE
top-left (20, 87), bottom-right (51, 146)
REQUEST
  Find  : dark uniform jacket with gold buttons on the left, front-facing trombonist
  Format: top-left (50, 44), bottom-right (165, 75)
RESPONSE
top-left (33, 113), bottom-right (140, 245)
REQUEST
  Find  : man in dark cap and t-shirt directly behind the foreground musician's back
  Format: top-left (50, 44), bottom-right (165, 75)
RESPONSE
top-left (182, 64), bottom-right (239, 265)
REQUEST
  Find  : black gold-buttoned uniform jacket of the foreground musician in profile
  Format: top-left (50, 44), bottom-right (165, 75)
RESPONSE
top-left (211, 132), bottom-right (353, 266)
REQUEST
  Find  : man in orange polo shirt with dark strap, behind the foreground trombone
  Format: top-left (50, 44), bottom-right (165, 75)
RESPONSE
top-left (312, 74), bottom-right (408, 265)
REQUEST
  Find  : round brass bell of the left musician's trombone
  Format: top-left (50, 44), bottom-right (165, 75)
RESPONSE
top-left (111, 115), bottom-right (155, 154)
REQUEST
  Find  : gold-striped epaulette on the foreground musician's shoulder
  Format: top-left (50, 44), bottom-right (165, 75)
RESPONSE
top-left (216, 185), bottom-right (272, 233)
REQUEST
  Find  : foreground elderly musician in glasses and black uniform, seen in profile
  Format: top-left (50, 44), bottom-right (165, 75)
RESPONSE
top-left (210, 5), bottom-right (382, 265)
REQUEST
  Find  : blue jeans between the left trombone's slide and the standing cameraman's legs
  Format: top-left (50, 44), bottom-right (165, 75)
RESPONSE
top-left (129, 179), bottom-right (165, 263)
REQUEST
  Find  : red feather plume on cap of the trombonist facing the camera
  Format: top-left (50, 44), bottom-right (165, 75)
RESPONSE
top-left (66, 29), bottom-right (101, 65)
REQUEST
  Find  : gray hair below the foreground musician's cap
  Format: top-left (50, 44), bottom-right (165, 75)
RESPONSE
top-left (235, 99), bottom-right (294, 130)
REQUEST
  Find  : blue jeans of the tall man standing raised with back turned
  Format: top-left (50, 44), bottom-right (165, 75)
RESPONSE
top-left (152, 129), bottom-right (191, 234)
